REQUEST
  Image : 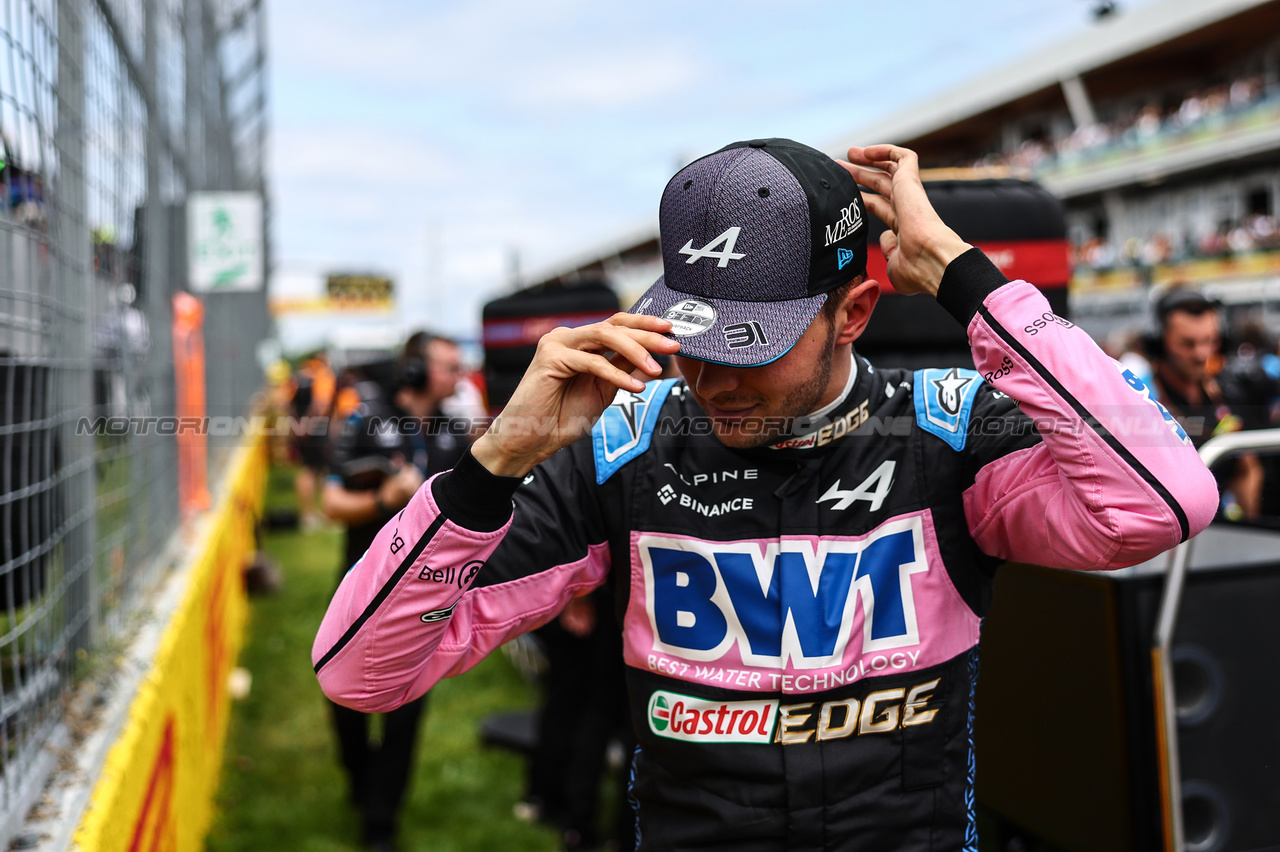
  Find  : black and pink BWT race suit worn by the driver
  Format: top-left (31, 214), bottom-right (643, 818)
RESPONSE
top-left (314, 251), bottom-right (1217, 852)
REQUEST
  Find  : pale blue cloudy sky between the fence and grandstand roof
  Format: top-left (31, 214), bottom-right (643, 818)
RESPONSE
top-left (266, 0), bottom-right (1146, 347)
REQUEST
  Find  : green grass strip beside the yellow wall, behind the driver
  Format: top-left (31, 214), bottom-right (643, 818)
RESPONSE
top-left (206, 468), bottom-right (557, 852)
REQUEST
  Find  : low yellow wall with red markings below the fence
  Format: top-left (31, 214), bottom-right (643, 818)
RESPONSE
top-left (76, 440), bottom-right (268, 852)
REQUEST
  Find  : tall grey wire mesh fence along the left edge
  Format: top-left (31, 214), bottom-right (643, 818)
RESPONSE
top-left (0, 0), bottom-right (270, 834)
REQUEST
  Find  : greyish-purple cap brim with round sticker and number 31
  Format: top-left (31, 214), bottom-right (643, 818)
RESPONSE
top-left (630, 278), bottom-right (827, 367)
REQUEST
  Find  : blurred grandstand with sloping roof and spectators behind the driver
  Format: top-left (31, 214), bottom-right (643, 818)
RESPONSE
top-left (517, 0), bottom-right (1280, 347)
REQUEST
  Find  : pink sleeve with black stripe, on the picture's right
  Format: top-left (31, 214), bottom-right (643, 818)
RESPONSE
top-left (964, 273), bottom-right (1217, 569)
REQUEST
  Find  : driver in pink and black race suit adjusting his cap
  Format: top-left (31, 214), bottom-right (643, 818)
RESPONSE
top-left (312, 139), bottom-right (1217, 852)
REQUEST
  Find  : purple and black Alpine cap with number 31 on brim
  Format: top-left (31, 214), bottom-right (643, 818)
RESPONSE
top-left (631, 139), bottom-right (867, 367)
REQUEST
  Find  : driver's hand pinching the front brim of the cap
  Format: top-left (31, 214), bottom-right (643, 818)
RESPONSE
top-left (471, 313), bottom-right (680, 476)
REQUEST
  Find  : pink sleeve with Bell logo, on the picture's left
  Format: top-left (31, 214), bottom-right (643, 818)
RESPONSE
top-left (311, 472), bottom-right (608, 713)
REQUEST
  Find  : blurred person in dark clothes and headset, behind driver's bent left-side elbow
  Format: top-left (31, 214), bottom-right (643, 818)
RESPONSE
top-left (323, 357), bottom-right (467, 852)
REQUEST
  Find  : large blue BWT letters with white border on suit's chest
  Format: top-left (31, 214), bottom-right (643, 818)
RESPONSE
top-left (636, 516), bottom-right (929, 669)
